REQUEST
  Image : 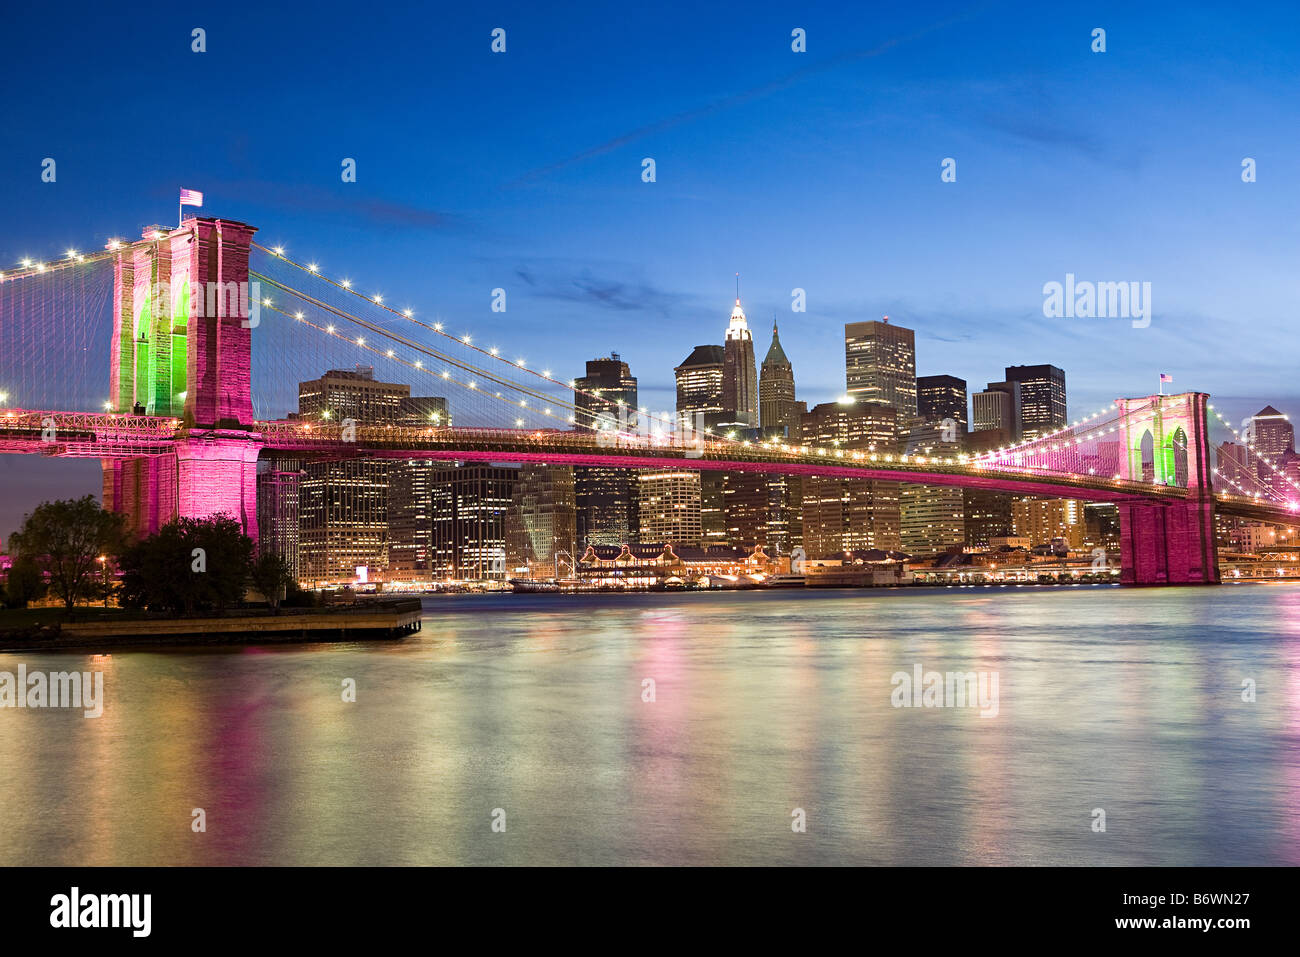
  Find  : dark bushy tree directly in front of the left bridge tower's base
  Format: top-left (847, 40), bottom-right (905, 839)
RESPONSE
top-left (120, 515), bottom-right (252, 615)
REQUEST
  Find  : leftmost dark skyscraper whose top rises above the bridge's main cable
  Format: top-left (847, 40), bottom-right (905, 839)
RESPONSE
top-left (573, 352), bottom-right (640, 549)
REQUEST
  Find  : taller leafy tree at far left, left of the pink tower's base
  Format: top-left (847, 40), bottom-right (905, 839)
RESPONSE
top-left (9, 495), bottom-right (122, 609)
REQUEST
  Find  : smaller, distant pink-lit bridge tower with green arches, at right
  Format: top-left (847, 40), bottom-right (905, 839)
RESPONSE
top-left (1117, 393), bottom-right (1219, 585)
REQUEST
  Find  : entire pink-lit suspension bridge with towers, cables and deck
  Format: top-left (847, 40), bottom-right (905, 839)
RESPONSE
top-left (0, 217), bottom-right (1300, 585)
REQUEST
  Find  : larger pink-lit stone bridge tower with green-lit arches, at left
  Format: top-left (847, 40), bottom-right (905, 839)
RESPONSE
top-left (103, 217), bottom-right (261, 538)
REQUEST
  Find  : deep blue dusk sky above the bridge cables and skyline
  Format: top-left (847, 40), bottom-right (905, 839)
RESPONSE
top-left (0, 3), bottom-right (1300, 532)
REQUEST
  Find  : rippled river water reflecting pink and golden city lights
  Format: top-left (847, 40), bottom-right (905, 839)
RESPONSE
top-left (0, 586), bottom-right (1300, 865)
